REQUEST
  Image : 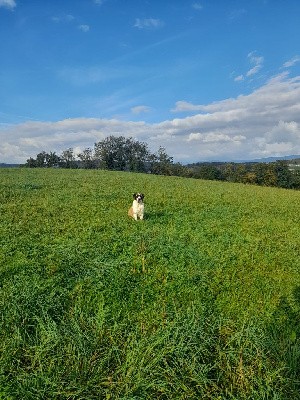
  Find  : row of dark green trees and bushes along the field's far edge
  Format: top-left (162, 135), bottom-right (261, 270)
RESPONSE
top-left (24, 136), bottom-right (300, 189)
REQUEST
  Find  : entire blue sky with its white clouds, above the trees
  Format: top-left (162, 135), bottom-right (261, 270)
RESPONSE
top-left (0, 0), bottom-right (300, 163)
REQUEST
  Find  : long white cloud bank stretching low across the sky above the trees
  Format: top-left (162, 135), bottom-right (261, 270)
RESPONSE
top-left (0, 73), bottom-right (300, 162)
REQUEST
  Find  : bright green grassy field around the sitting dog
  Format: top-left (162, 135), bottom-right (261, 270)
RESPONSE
top-left (0, 169), bottom-right (300, 400)
